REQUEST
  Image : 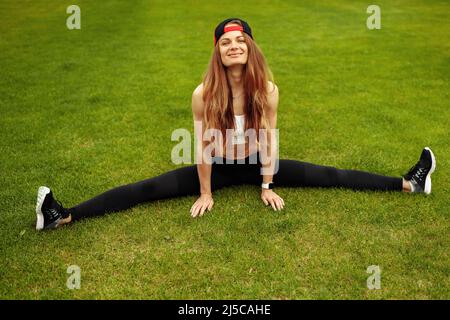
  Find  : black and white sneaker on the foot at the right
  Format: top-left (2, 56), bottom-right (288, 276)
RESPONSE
top-left (403, 147), bottom-right (436, 194)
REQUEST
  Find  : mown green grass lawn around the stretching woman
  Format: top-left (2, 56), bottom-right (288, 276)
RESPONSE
top-left (0, 0), bottom-right (450, 299)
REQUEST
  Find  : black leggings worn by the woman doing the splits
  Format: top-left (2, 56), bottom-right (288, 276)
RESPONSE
top-left (69, 154), bottom-right (403, 220)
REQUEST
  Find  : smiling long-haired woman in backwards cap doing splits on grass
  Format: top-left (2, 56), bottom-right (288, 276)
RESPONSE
top-left (36, 18), bottom-right (436, 230)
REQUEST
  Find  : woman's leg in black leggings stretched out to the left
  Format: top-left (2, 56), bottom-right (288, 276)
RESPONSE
top-left (68, 165), bottom-right (236, 221)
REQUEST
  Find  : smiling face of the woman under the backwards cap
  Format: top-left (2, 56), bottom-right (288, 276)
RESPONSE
top-left (218, 23), bottom-right (248, 67)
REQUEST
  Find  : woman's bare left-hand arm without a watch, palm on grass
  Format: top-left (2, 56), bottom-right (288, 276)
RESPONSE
top-left (191, 84), bottom-right (214, 218)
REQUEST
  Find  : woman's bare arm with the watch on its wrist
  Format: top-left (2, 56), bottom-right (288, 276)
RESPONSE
top-left (261, 82), bottom-right (284, 211)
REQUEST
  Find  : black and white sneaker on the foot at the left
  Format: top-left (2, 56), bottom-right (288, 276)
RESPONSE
top-left (36, 187), bottom-right (69, 230)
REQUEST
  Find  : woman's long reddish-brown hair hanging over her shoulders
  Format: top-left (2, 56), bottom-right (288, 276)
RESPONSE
top-left (203, 20), bottom-right (273, 149)
